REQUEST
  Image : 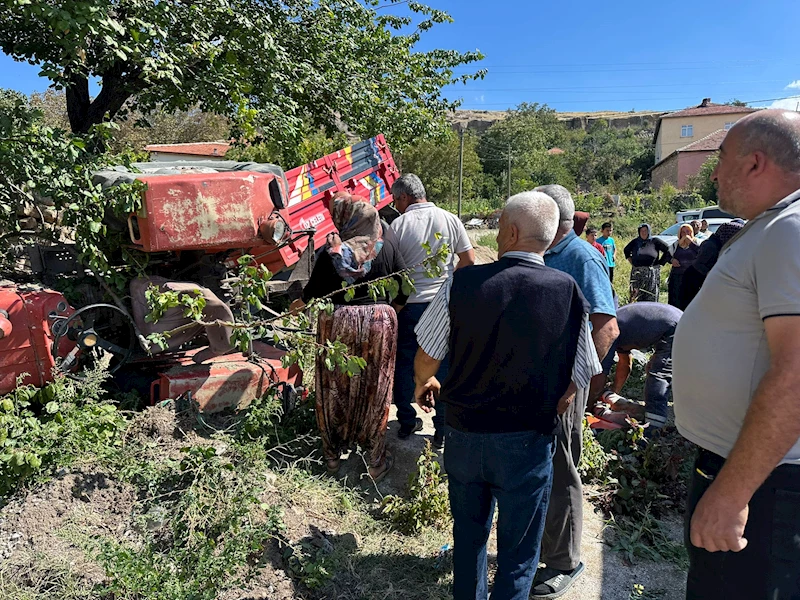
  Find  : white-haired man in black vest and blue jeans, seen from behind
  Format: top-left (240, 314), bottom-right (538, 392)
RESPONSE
top-left (414, 192), bottom-right (601, 600)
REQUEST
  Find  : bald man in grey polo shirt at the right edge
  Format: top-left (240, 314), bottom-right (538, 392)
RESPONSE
top-left (672, 110), bottom-right (800, 600)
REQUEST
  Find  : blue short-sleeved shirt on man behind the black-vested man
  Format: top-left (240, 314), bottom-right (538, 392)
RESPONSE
top-left (544, 231), bottom-right (617, 317)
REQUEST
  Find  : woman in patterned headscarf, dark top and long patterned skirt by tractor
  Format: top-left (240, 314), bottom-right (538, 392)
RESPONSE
top-left (303, 193), bottom-right (407, 482)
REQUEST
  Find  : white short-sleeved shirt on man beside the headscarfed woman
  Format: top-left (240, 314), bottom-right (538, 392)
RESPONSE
top-left (392, 202), bottom-right (472, 304)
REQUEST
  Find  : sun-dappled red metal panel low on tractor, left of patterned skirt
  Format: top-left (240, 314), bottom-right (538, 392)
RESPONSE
top-left (151, 342), bottom-right (303, 413)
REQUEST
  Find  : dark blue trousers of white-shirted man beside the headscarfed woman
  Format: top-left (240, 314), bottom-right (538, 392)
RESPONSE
top-left (394, 302), bottom-right (448, 431)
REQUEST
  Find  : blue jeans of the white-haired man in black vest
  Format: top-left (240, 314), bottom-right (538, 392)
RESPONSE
top-left (444, 427), bottom-right (555, 600)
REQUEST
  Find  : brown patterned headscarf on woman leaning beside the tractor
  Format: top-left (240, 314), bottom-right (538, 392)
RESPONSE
top-left (326, 192), bottom-right (383, 284)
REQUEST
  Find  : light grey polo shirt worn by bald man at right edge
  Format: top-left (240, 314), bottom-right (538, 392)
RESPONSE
top-left (672, 190), bottom-right (800, 465)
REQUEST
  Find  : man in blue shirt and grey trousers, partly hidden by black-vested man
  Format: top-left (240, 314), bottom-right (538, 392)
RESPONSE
top-left (531, 185), bottom-right (619, 598)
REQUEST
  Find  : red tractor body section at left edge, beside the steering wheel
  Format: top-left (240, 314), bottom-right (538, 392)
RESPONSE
top-left (0, 285), bottom-right (74, 394)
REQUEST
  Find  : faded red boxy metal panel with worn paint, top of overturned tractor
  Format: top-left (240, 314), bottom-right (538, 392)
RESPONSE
top-left (131, 172), bottom-right (282, 252)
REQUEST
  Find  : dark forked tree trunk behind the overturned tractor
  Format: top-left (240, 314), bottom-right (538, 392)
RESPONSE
top-left (66, 73), bottom-right (131, 134)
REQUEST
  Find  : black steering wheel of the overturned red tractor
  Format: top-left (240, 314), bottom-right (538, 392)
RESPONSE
top-left (50, 304), bottom-right (136, 379)
